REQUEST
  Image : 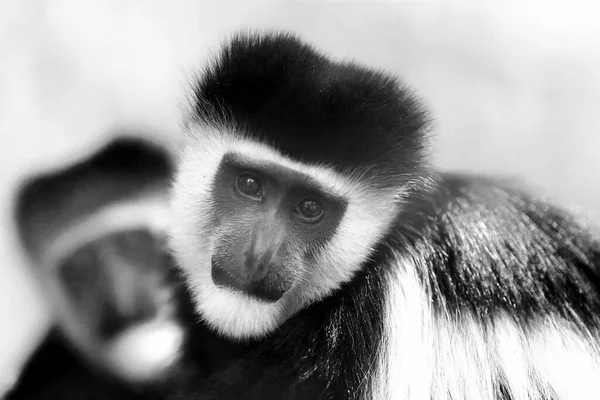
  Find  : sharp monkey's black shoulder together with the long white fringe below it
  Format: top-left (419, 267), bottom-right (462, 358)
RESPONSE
top-left (374, 175), bottom-right (600, 399)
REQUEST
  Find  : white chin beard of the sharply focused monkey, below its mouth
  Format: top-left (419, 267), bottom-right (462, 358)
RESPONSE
top-left (194, 281), bottom-right (290, 342)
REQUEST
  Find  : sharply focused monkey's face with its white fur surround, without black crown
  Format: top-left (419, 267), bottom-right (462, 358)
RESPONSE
top-left (170, 127), bottom-right (400, 339)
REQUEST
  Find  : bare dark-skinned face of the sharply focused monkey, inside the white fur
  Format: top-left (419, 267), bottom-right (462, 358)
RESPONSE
top-left (211, 153), bottom-right (347, 302)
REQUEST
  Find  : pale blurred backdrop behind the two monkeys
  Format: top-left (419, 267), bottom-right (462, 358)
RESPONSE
top-left (0, 0), bottom-right (600, 393)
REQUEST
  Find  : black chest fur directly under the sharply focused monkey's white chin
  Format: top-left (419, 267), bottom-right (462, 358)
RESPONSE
top-left (162, 256), bottom-right (386, 400)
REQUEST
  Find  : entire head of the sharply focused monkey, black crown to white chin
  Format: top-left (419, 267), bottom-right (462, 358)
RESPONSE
top-left (170, 33), bottom-right (426, 339)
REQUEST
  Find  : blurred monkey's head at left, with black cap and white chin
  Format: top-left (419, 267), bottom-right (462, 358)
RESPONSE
top-left (16, 138), bottom-right (185, 398)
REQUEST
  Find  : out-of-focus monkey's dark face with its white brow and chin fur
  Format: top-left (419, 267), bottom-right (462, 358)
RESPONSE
top-left (43, 203), bottom-right (185, 383)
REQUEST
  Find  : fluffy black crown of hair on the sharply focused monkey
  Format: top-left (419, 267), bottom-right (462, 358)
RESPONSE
top-left (194, 33), bottom-right (426, 184)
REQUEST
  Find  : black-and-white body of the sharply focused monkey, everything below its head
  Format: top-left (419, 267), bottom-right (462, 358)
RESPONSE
top-left (168, 176), bottom-right (600, 400)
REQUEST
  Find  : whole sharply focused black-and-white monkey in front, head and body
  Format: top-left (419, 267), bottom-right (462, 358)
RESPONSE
top-left (170, 33), bottom-right (600, 400)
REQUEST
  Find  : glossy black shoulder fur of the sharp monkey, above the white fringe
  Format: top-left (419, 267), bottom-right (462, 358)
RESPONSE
top-left (390, 174), bottom-right (600, 325)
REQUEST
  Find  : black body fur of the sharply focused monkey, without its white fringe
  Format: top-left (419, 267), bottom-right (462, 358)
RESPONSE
top-left (168, 175), bottom-right (600, 399)
